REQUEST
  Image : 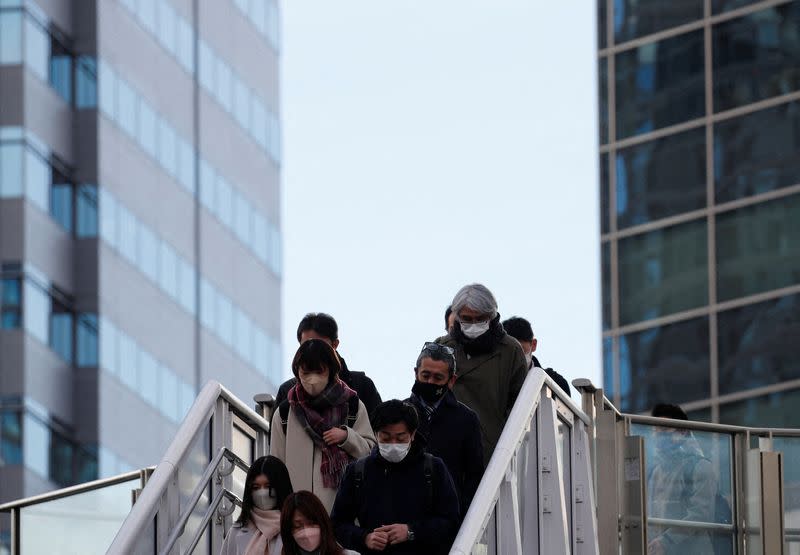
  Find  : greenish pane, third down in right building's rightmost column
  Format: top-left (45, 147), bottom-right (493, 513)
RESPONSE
top-left (717, 194), bottom-right (800, 301)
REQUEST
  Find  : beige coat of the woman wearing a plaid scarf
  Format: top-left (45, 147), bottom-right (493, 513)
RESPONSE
top-left (269, 401), bottom-right (375, 513)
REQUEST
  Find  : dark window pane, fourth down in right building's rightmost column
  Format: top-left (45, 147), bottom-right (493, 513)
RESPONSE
top-left (717, 295), bottom-right (800, 395)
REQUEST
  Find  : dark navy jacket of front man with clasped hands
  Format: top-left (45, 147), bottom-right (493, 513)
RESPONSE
top-left (331, 441), bottom-right (459, 555)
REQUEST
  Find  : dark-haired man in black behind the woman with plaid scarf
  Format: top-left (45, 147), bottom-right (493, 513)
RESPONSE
top-left (275, 312), bottom-right (381, 420)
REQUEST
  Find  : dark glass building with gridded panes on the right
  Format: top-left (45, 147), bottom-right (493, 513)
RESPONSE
top-left (597, 0), bottom-right (800, 427)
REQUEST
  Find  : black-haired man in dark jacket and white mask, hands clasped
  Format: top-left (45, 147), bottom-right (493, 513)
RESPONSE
top-left (331, 399), bottom-right (459, 555)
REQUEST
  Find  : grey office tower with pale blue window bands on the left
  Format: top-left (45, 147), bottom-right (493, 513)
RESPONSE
top-left (0, 0), bottom-right (282, 551)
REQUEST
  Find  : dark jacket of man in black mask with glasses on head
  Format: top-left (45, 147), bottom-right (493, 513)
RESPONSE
top-left (408, 391), bottom-right (484, 519)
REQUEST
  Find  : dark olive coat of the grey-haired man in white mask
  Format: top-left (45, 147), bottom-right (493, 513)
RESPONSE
top-left (436, 332), bottom-right (528, 464)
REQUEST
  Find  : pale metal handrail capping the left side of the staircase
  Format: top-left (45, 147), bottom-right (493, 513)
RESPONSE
top-left (108, 380), bottom-right (269, 554)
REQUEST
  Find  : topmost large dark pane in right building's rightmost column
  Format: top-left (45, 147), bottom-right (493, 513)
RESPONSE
top-left (713, 2), bottom-right (800, 112)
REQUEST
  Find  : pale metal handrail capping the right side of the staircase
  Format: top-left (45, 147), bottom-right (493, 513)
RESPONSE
top-left (450, 371), bottom-right (589, 555)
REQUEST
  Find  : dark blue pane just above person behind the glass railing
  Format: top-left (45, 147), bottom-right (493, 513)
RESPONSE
top-left (619, 317), bottom-right (710, 412)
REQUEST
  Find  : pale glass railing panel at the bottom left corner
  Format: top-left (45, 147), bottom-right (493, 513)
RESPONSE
top-left (20, 478), bottom-right (141, 555)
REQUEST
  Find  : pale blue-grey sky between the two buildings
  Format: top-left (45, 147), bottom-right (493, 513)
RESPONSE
top-left (282, 0), bottom-right (601, 399)
